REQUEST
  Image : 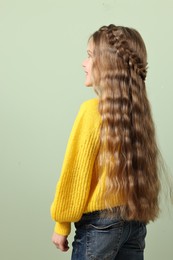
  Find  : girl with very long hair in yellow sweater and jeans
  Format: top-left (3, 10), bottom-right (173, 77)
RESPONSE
top-left (51, 24), bottom-right (171, 260)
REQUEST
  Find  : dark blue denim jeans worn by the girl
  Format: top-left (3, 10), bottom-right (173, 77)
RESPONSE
top-left (71, 211), bottom-right (146, 260)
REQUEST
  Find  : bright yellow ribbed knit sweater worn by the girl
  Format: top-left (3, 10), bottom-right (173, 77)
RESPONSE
top-left (51, 99), bottom-right (123, 235)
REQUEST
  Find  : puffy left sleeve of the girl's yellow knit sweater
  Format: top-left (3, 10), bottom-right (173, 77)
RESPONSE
top-left (51, 100), bottom-right (100, 235)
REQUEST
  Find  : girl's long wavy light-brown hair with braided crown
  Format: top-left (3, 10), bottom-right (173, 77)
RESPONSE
top-left (90, 24), bottom-right (160, 223)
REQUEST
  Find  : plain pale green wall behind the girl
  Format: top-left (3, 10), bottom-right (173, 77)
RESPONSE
top-left (0, 0), bottom-right (173, 260)
